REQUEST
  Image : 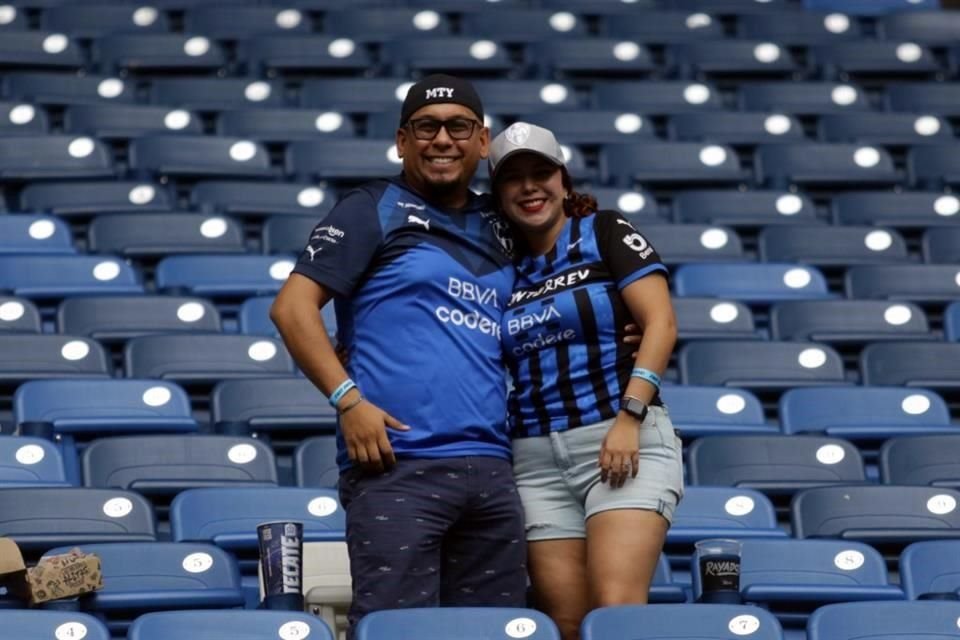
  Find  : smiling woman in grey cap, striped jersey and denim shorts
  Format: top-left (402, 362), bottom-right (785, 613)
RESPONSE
top-left (489, 122), bottom-right (683, 640)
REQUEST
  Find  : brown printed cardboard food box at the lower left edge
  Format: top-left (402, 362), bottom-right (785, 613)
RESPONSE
top-left (0, 538), bottom-right (103, 604)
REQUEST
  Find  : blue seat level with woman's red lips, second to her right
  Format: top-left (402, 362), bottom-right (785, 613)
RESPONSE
top-left (673, 190), bottom-right (817, 227)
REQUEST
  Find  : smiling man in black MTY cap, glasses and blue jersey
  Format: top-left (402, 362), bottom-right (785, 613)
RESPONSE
top-left (271, 75), bottom-right (526, 629)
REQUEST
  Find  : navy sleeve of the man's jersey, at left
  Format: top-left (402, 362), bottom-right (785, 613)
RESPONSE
top-left (293, 189), bottom-right (383, 296)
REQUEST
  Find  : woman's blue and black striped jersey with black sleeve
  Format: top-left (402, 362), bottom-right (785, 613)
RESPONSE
top-left (503, 211), bottom-right (667, 437)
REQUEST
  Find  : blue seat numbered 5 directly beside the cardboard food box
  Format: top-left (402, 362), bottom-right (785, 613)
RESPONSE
top-left (44, 542), bottom-right (243, 633)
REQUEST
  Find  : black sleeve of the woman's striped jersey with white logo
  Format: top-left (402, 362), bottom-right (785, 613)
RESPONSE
top-left (593, 211), bottom-right (669, 289)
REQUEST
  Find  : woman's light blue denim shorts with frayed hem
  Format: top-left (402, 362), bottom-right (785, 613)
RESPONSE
top-left (513, 406), bottom-right (683, 541)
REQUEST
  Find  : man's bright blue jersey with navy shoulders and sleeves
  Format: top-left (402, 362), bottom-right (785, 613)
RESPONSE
top-left (294, 178), bottom-right (515, 468)
